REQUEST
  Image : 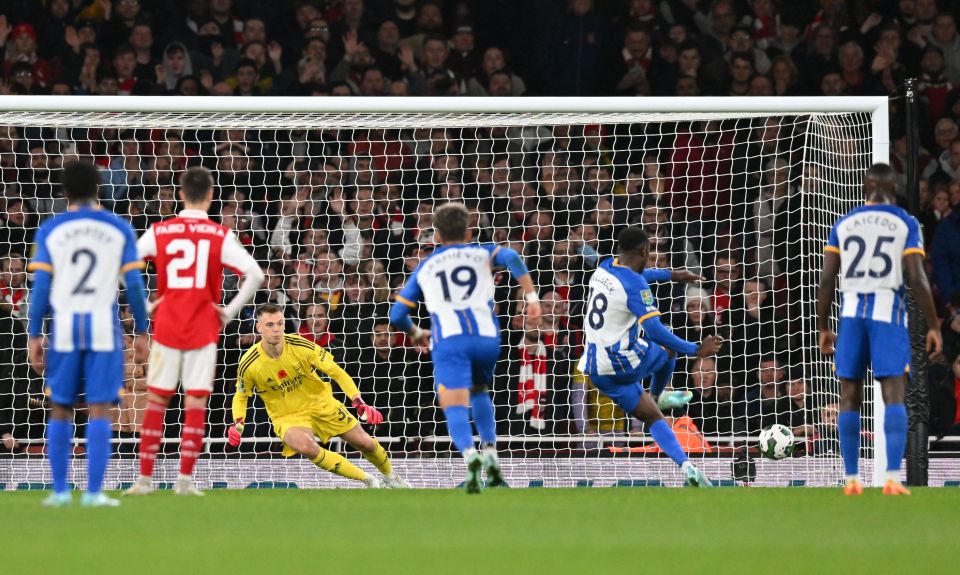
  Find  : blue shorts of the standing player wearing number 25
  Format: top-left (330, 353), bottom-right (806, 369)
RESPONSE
top-left (834, 317), bottom-right (910, 381)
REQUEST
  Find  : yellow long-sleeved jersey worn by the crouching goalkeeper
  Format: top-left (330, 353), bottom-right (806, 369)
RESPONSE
top-left (233, 334), bottom-right (360, 420)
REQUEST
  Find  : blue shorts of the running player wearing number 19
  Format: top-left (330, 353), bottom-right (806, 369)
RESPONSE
top-left (431, 335), bottom-right (500, 391)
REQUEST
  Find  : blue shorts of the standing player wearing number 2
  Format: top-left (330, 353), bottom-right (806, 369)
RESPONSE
top-left (45, 350), bottom-right (123, 405)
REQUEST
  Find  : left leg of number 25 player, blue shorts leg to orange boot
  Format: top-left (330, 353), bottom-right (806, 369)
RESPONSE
top-left (834, 318), bottom-right (869, 495)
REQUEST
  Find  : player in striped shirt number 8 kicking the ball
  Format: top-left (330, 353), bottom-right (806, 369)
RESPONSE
top-left (579, 226), bottom-right (723, 487)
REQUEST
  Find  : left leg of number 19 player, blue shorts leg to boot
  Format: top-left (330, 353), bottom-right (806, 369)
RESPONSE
top-left (433, 338), bottom-right (483, 493)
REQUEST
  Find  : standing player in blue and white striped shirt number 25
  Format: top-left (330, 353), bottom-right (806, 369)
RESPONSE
top-left (817, 164), bottom-right (943, 495)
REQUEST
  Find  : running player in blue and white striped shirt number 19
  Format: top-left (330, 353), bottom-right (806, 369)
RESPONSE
top-left (390, 203), bottom-right (540, 493)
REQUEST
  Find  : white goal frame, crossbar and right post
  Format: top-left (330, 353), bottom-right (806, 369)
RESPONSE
top-left (0, 96), bottom-right (890, 485)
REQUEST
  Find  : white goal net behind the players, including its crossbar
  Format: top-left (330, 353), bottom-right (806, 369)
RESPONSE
top-left (0, 98), bottom-right (916, 489)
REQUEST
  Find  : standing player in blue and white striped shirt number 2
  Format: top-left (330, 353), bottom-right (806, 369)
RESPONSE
top-left (28, 163), bottom-right (148, 507)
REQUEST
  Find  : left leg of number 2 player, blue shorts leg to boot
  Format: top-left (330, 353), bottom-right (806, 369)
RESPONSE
top-left (43, 349), bottom-right (80, 507)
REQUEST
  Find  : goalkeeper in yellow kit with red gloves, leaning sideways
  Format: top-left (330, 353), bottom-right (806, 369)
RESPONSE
top-left (227, 304), bottom-right (410, 487)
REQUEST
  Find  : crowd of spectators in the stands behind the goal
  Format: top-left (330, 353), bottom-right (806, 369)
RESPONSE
top-left (0, 0), bottom-right (960, 460)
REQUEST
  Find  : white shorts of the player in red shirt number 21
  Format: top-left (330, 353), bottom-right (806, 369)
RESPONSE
top-left (147, 341), bottom-right (217, 396)
